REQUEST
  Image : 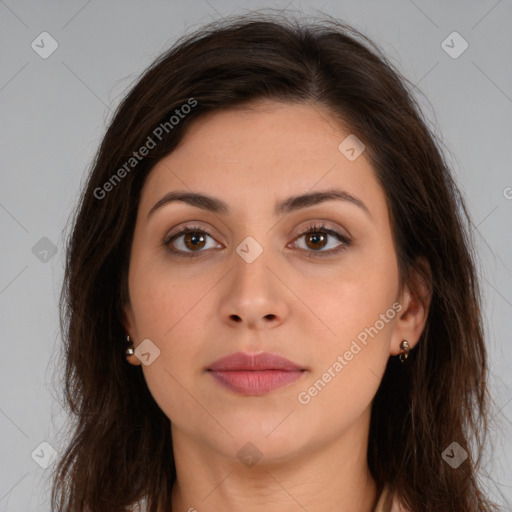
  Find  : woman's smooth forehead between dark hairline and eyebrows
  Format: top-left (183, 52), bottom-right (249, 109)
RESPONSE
top-left (141, 102), bottom-right (385, 223)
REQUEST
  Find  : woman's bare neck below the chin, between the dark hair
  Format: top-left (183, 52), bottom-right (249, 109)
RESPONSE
top-left (167, 408), bottom-right (378, 512)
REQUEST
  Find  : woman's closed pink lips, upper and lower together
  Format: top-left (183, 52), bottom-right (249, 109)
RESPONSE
top-left (207, 352), bottom-right (306, 396)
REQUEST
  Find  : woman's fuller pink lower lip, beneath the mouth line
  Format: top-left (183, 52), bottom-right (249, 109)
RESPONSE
top-left (209, 370), bottom-right (304, 396)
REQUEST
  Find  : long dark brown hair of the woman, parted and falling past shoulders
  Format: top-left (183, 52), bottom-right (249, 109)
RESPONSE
top-left (51, 9), bottom-right (495, 512)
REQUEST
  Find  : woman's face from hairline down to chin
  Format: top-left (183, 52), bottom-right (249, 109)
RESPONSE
top-left (125, 102), bottom-right (423, 468)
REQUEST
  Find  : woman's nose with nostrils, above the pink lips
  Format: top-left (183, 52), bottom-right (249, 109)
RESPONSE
top-left (220, 252), bottom-right (292, 330)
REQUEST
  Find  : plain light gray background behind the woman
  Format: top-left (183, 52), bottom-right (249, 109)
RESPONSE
top-left (0, 0), bottom-right (512, 512)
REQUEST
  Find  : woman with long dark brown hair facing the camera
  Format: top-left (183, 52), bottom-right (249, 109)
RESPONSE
top-left (52, 10), bottom-right (494, 512)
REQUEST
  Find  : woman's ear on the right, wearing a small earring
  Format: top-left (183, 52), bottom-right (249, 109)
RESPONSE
top-left (390, 257), bottom-right (432, 355)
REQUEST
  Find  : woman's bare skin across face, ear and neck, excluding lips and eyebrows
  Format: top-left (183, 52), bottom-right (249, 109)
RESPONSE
top-left (124, 102), bottom-right (428, 512)
